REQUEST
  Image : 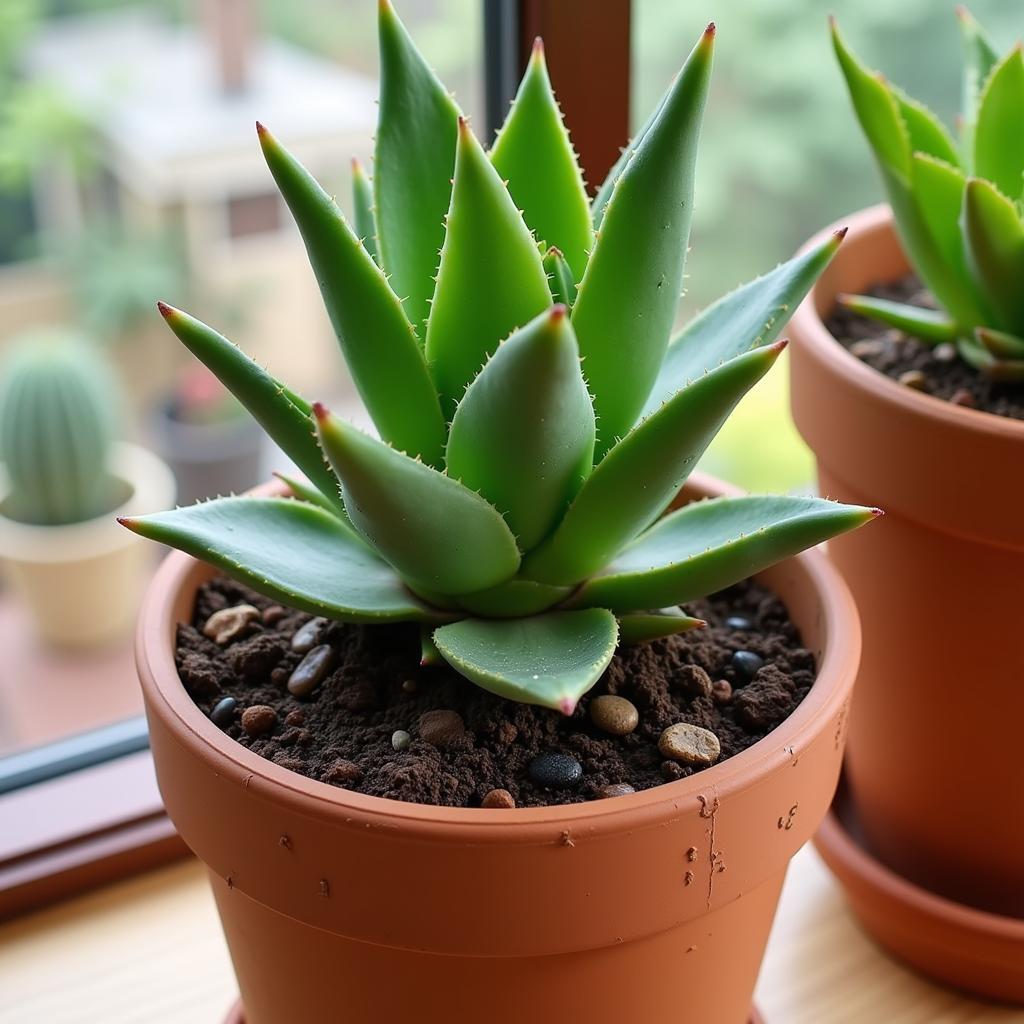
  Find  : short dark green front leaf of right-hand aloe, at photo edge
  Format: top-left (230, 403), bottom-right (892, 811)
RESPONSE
top-left (962, 178), bottom-right (1024, 333)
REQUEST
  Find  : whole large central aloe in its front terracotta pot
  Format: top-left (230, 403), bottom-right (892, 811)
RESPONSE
top-left (123, 2), bottom-right (877, 1024)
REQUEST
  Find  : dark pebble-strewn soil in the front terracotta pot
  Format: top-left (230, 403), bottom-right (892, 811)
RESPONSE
top-left (176, 578), bottom-right (815, 807)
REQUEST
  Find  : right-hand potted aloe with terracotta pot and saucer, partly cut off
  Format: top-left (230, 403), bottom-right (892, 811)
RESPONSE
top-left (792, 9), bottom-right (1024, 999)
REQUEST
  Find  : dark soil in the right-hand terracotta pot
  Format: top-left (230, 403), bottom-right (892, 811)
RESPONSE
top-left (825, 273), bottom-right (1024, 420)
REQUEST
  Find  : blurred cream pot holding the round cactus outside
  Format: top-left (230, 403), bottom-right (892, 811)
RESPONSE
top-left (0, 443), bottom-right (174, 647)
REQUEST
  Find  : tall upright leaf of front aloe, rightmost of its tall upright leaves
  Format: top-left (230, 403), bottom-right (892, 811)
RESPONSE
top-left (572, 28), bottom-right (714, 459)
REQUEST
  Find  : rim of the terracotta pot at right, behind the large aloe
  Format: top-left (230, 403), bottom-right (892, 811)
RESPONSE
top-left (791, 203), bottom-right (1024, 443)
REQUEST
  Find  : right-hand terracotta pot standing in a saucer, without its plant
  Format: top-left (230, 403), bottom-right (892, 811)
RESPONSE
top-left (790, 207), bottom-right (1024, 987)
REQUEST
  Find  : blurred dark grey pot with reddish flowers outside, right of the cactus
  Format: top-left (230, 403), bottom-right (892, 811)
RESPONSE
top-left (150, 366), bottom-right (263, 505)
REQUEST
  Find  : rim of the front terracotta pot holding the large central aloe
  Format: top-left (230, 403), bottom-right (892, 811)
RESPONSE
top-left (135, 473), bottom-right (860, 845)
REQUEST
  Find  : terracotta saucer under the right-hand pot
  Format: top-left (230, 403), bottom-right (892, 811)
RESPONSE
top-left (814, 785), bottom-right (1024, 1004)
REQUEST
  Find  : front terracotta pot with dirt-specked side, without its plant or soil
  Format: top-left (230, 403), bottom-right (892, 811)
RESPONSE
top-left (137, 479), bottom-right (860, 1024)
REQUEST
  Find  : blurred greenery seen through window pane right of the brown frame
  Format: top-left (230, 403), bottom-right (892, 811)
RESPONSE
top-left (633, 0), bottom-right (1021, 489)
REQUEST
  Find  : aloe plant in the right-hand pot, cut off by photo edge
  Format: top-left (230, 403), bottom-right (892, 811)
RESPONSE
top-left (831, 7), bottom-right (1024, 381)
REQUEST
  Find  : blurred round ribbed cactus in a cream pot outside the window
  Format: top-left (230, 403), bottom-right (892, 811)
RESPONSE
top-left (0, 329), bottom-right (174, 647)
